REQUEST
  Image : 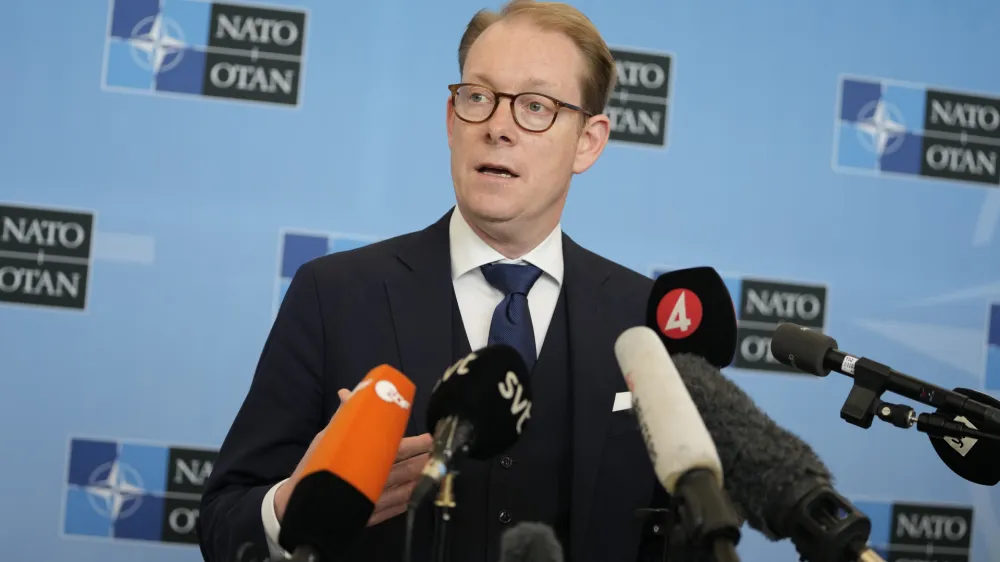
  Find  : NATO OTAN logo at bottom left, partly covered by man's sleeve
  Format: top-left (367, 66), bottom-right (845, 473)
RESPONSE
top-left (62, 438), bottom-right (218, 544)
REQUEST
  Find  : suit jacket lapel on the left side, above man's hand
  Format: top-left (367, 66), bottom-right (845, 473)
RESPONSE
top-left (385, 211), bottom-right (454, 435)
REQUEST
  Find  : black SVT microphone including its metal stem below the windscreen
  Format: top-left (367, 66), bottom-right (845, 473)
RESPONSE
top-left (409, 344), bottom-right (532, 510)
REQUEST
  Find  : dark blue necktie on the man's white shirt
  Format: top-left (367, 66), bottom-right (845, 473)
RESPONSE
top-left (480, 263), bottom-right (542, 372)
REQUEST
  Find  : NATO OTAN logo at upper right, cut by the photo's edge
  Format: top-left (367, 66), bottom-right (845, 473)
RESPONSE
top-left (833, 77), bottom-right (1000, 186)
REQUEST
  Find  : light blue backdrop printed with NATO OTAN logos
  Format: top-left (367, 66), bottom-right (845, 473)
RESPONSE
top-left (0, 0), bottom-right (1000, 562)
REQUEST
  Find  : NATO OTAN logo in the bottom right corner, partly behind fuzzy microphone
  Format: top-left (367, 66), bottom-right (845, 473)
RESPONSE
top-left (854, 501), bottom-right (973, 562)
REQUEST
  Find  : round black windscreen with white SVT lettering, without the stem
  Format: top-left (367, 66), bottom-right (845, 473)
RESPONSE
top-left (427, 344), bottom-right (532, 460)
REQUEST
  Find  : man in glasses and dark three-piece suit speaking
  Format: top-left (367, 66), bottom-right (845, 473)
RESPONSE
top-left (199, 1), bottom-right (660, 562)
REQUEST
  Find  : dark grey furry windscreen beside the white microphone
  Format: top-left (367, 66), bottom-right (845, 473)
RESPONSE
top-left (673, 353), bottom-right (833, 538)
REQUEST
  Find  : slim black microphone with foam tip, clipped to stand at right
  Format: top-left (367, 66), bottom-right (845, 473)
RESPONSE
top-left (771, 323), bottom-right (1000, 431)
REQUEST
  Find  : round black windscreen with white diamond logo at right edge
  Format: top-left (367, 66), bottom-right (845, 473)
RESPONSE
top-left (930, 388), bottom-right (1000, 486)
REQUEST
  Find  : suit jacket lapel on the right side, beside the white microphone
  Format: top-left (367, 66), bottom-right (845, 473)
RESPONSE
top-left (563, 236), bottom-right (620, 560)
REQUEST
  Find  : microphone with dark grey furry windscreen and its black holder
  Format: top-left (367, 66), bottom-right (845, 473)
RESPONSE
top-left (673, 353), bottom-right (885, 562)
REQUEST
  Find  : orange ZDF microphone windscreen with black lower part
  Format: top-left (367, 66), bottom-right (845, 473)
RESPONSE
top-left (278, 365), bottom-right (416, 562)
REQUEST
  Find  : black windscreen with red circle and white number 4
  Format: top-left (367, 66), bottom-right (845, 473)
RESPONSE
top-left (646, 267), bottom-right (736, 368)
